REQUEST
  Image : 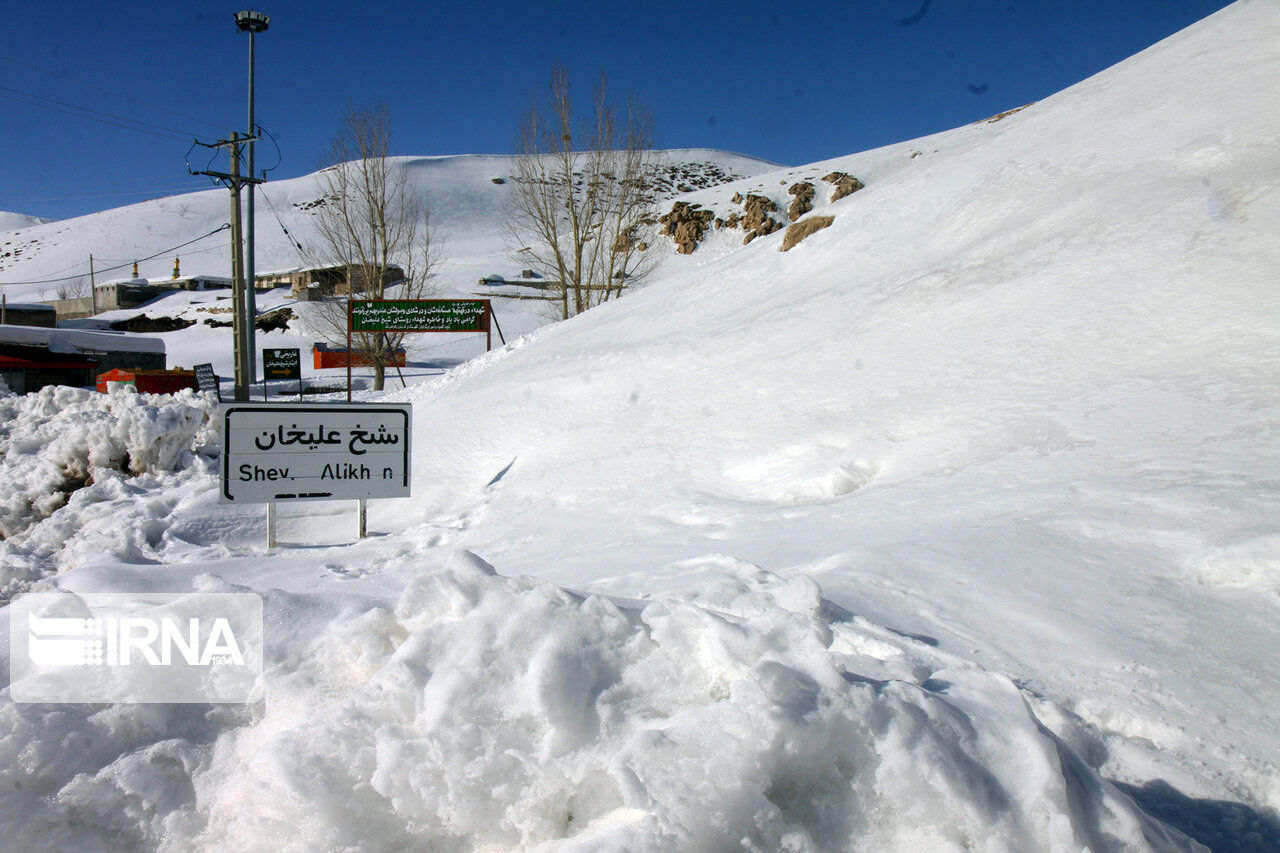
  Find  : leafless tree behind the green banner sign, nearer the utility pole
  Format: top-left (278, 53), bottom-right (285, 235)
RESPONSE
top-left (306, 105), bottom-right (439, 391)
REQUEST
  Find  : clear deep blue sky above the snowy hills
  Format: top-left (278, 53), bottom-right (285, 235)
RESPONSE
top-left (0, 0), bottom-right (1228, 218)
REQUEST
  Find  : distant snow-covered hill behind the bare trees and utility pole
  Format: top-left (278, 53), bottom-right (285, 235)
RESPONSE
top-left (0, 149), bottom-right (777, 301)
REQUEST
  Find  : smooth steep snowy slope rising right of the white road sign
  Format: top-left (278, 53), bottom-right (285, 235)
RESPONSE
top-left (386, 0), bottom-right (1280, 808)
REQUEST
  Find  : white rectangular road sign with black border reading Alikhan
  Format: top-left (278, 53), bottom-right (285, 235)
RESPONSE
top-left (223, 403), bottom-right (412, 503)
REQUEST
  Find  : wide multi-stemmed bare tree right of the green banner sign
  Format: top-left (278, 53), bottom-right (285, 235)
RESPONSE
top-left (507, 67), bottom-right (654, 318)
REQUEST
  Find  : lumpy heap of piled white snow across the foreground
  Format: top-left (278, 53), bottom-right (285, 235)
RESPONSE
top-left (0, 552), bottom-right (1196, 850)
